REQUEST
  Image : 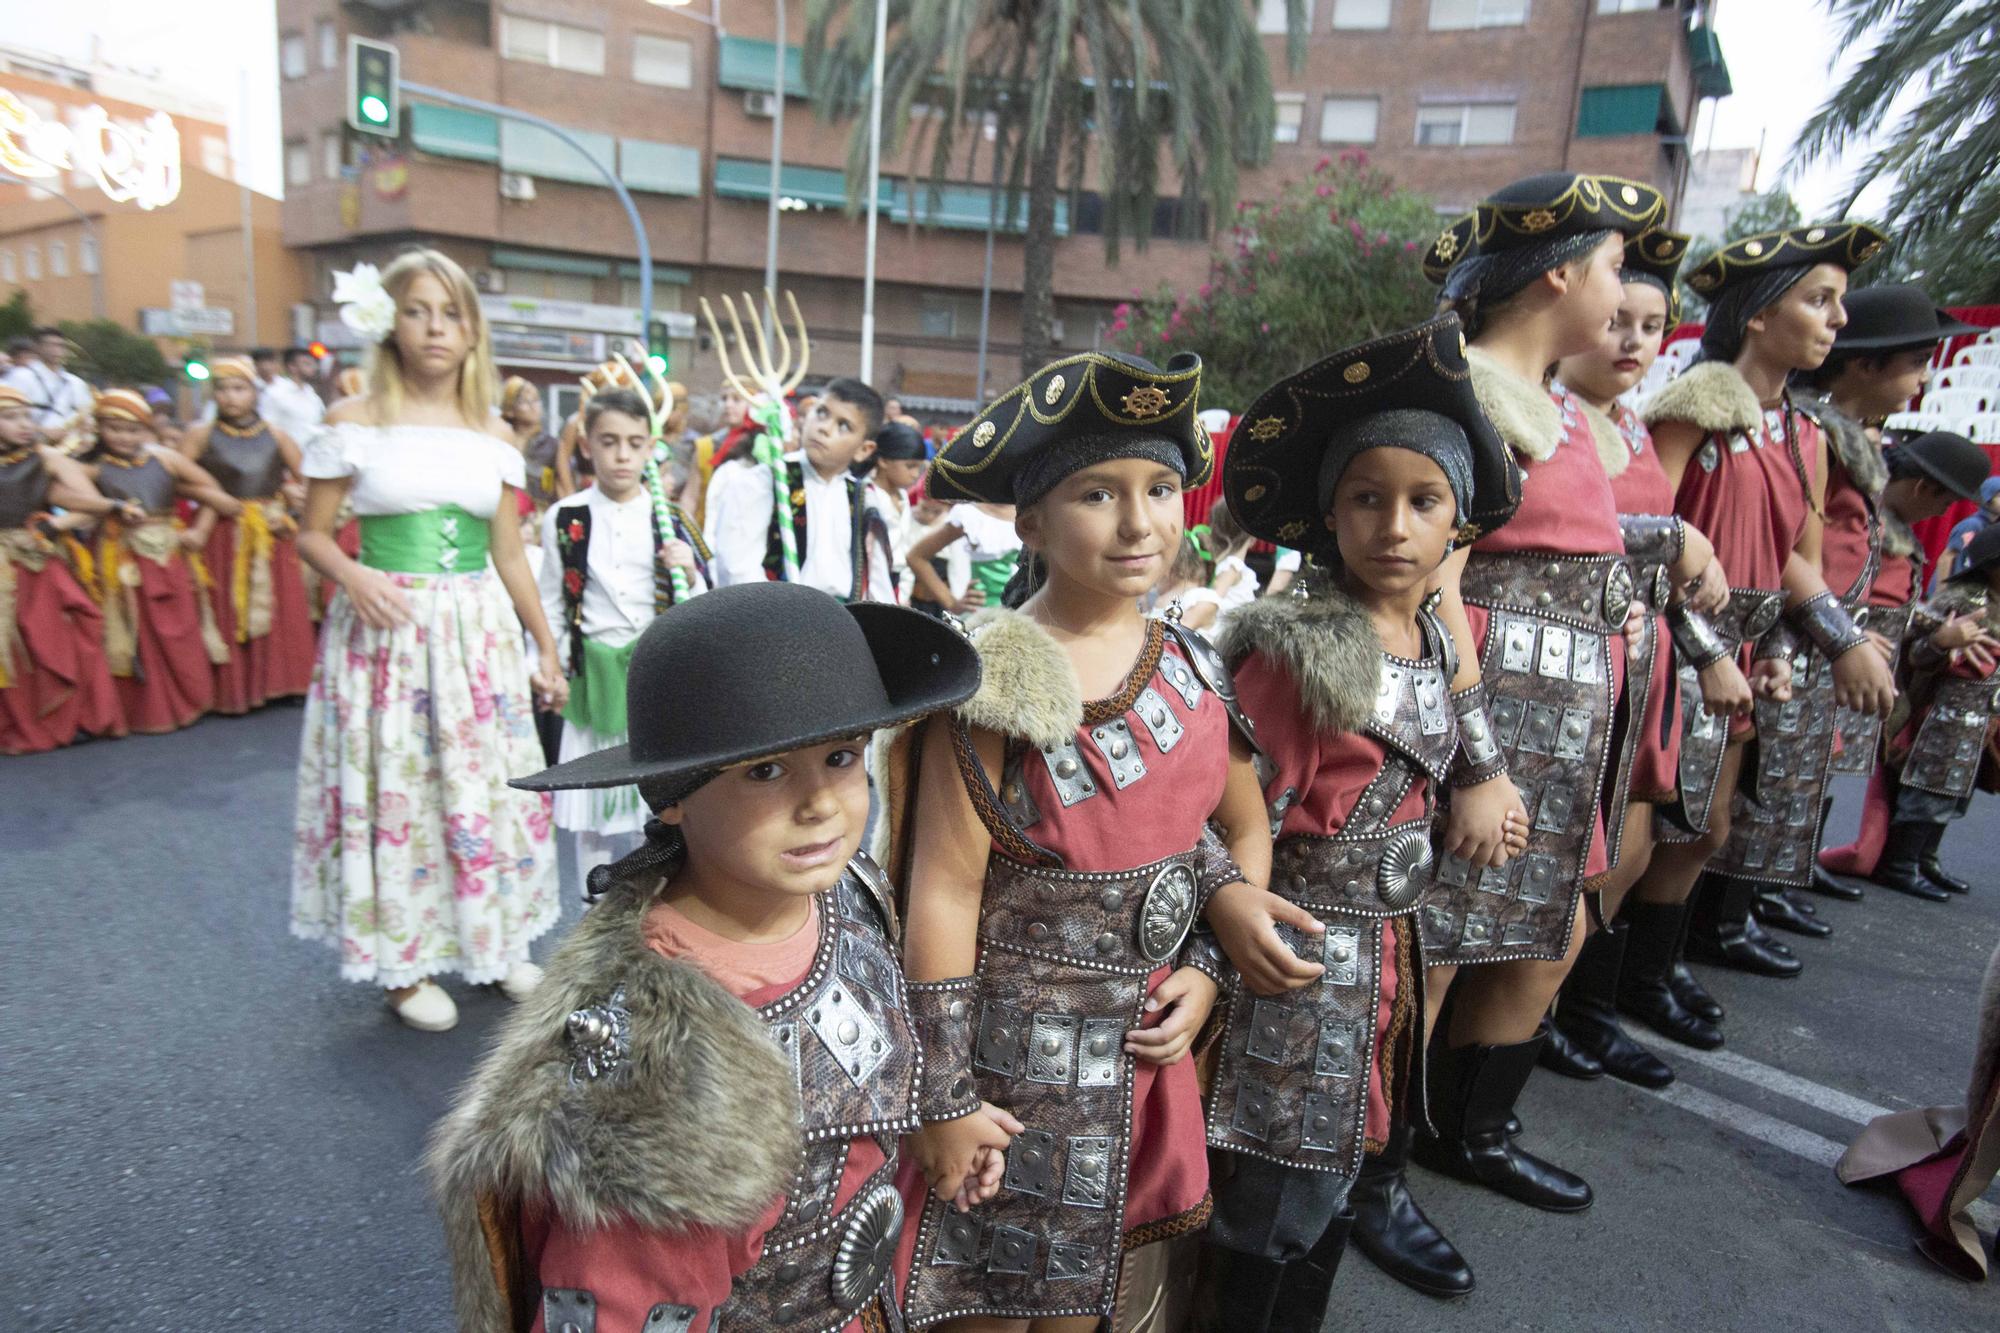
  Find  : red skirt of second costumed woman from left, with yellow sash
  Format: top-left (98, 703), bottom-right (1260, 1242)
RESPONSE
top-left (98, 532), bottom-right (218, 735)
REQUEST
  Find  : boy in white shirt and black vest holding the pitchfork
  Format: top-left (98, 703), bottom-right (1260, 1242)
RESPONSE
top-left (708, 378), bottom-right (896, 602)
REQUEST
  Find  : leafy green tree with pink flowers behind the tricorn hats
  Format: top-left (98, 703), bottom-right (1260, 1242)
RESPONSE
top-left (1110, 148), bottom-right (1440, 410)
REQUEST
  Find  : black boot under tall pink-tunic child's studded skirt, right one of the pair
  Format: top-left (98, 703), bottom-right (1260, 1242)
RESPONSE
top-left (1416, 1033), bottom-right (1590, 1213)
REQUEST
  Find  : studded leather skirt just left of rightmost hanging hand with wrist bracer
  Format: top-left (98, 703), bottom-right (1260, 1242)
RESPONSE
top-left (1710, 648), bottom-right (1834, 889)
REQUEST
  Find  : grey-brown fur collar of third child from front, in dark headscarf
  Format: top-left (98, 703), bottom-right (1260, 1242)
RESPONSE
top-left (1218, 584), bottom-right (1382, 733)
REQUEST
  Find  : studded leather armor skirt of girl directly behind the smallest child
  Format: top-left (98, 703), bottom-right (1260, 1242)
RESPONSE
top-left (906, 853), bottom-right (1196, 1327)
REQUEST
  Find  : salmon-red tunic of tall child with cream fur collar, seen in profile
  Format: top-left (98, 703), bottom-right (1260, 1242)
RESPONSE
top-left (1466, 384), bottom-right (1626, 879)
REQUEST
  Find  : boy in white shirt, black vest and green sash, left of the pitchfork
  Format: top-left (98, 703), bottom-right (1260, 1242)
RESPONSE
top-left (538, 388), bottom-right (710, 893)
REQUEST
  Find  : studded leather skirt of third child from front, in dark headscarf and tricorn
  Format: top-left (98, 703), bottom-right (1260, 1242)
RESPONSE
top-left (1208, 819), bottom-right (1430, 1179)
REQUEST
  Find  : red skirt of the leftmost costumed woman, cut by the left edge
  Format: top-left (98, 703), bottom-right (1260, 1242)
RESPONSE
top-left (0, 536), bottom-right (126, 755)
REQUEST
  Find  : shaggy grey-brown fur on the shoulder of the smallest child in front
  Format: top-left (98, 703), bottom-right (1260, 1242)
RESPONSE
top-left (424, 881), bottom-right (800, 1331)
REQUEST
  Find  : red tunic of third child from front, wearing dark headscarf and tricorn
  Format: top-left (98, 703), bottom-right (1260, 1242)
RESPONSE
top-left (1236, 652), bottom-right (1430, 1143)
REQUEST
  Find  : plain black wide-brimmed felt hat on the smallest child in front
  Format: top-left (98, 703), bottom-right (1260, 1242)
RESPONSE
top-left (510, 582), bottom-right (980, 791)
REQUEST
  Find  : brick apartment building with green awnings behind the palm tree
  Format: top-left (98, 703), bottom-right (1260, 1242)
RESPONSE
top-left (278, 0), bottom-right (1728, 410)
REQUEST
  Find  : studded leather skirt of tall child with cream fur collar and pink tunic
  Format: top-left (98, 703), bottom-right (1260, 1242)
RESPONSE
top-left (1420, 550), bottom-right (1634, 965)
